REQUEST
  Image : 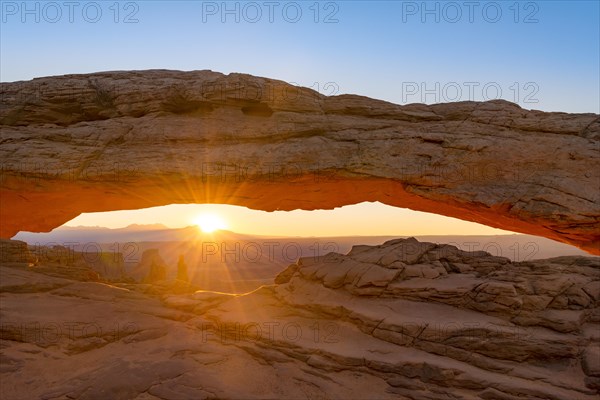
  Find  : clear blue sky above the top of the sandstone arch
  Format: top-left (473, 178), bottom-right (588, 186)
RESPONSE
top-left (0, 1), bottom-right (600, 113)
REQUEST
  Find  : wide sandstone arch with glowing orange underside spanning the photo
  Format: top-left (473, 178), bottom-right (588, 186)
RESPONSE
top-left (0, 70), bottom-right (600, 254)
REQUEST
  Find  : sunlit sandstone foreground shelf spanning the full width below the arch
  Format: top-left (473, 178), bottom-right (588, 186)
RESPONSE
top-left (0, 239), bottom-right (600, 400)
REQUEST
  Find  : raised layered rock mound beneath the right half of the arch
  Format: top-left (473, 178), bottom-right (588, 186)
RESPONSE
top-left (275, 238), bottom-right (600, 322)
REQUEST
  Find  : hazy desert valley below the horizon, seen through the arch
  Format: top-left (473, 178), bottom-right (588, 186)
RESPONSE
top-left (14, 225), bottom-right (587, 293)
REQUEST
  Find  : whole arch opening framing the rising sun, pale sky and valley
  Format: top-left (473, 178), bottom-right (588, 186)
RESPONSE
top-left (13, 202), bottom-right (585, 293)
